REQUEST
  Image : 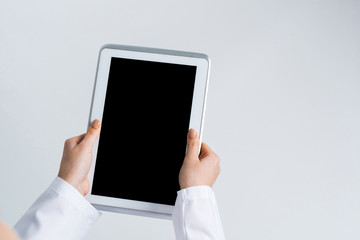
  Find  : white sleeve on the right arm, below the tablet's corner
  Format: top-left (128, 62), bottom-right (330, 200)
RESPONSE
top-left (173, 186), bottom-right (225, 240)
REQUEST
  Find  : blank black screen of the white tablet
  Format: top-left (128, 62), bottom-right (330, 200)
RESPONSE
top-left (92, 58), bottom-right (196, 205)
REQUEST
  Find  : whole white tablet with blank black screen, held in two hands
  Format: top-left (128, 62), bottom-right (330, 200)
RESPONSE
top-left (86, 45), bottom-right (210, 219)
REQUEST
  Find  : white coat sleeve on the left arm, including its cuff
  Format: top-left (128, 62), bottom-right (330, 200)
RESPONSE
top-left (14, 177), bottom-right (100, 240)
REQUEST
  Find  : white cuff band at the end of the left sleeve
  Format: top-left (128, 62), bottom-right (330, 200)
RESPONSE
top-left (49, 177), bottom-right (101, 221)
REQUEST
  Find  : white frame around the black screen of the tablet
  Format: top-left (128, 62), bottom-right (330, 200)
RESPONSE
top-left (86, 44), bottom-right (210, 219)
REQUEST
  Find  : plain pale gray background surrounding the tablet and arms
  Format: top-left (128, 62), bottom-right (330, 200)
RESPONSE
top-left (0, 0), bottom-right (360, 240)
